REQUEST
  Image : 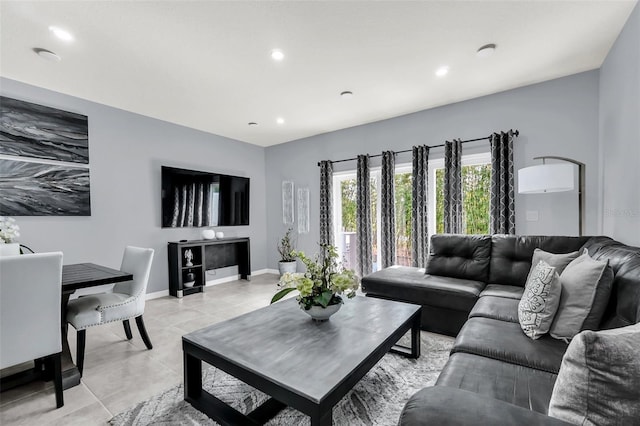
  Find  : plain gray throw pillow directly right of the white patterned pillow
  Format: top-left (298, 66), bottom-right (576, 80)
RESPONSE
top-left (549, 252), bottom-right (613, 339)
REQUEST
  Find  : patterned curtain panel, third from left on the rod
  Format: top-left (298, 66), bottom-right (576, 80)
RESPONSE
top-left (380, 151), bottom-right (396, 268)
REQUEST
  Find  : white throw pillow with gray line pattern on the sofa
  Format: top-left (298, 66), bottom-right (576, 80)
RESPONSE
top-left (518, 260), bottom-right (562, 339)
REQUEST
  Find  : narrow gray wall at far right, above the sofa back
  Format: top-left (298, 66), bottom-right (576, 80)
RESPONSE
top-left (600, 5), bottom-right (640, 246)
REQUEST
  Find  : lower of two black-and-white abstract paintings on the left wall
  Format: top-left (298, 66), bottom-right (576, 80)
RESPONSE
top-left (0, 159), bottom-right (91, 216)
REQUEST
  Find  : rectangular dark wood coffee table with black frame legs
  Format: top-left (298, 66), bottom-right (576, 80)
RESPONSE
top-left (182, 297), bottom-right (420, 426)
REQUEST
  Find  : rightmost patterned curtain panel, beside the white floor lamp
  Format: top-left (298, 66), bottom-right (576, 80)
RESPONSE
top-left (489, 131), bottom-right (516, 234)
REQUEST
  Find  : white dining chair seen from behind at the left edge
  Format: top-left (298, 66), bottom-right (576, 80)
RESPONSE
top-left (0, 252), bottom-right (64, 408)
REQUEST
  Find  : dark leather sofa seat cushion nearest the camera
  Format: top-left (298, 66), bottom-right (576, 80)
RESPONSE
top-left (436, 353), bottom-right (557, 414)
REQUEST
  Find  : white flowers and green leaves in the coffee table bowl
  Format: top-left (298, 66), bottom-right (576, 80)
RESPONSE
top-left (271, 244), bottom-right (360, 310)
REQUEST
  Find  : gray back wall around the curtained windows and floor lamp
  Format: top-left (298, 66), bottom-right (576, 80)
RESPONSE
top-left (266, 70), bottom-right (600, 267)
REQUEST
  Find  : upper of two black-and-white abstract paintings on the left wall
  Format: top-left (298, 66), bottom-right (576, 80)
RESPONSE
top-left (0, 96), bottom-right (89, 164)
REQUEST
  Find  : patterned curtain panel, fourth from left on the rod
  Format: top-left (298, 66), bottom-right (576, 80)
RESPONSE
top-left (411, 145), bottom-right (429, 268)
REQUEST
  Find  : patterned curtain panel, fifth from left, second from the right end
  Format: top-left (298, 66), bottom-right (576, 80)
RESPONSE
top-left (443, 140), bottom-right (464, 234)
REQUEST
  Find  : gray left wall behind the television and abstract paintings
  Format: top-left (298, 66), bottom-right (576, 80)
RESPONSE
top-left (0, 78), bottom-right (266, 292)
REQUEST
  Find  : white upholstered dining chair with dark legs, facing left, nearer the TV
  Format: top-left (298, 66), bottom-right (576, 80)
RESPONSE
top-left (67, 246), bottom-right (153, 375)
